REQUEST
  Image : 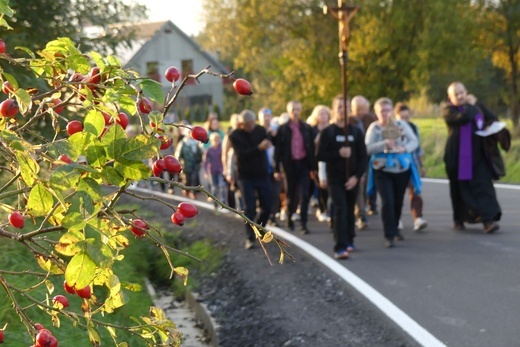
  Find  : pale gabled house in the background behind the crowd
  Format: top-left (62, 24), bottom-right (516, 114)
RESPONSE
top-left (116, 21), bottom-right (229, 120)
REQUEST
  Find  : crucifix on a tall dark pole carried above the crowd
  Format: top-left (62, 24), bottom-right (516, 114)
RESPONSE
top-left (323, 0), bottom-right (360, 180)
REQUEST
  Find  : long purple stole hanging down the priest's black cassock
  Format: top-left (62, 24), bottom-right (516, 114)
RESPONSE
top-left (458, 106), bottom-right (484, 181)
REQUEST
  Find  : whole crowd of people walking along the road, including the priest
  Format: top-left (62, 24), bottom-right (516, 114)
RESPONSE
top-left (142, 82), bottom-right (501, 259)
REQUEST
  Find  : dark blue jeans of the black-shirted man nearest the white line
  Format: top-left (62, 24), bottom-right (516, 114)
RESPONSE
top-left (238, 176), bottom-right (273, 241)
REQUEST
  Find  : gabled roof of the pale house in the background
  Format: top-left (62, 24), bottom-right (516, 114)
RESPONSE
top-left (118, 20), bottom-right (230, 74)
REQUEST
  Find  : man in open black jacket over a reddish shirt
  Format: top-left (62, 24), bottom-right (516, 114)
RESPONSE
top-left (274, 101), bottom-right (317, 234)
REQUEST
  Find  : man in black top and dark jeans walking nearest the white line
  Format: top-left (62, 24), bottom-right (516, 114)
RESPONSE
top-left (229, 110), bottom-right (272, 249)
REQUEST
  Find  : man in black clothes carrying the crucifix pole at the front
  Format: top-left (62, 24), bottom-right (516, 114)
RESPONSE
top-left (316, 95), bottom-right (368, 259)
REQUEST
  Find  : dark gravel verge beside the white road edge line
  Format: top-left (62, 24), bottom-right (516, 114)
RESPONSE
top-left (126, 193), bottom-right (417, 347)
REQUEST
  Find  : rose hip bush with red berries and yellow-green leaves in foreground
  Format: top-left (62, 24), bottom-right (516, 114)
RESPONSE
top-left (0, 6), bottom-right (290, 346)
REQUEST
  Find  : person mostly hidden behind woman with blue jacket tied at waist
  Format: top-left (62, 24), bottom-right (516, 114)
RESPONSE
top-left (394, 102), bottom-right (428, 232)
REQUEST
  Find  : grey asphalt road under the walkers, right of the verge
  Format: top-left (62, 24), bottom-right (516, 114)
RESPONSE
top-left (290, 180), bottom-right (520, 347)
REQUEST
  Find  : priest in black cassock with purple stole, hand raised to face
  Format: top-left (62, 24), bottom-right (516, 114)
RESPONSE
top-left (443, 82), bottom-right (502, 234)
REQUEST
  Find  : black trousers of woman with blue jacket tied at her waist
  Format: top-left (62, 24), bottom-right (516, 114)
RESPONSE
top-left (374, 170), bottom-right (410, 240)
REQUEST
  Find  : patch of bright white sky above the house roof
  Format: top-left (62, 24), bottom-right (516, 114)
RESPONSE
top-left (138, 0), bottom-right (203, 36)
